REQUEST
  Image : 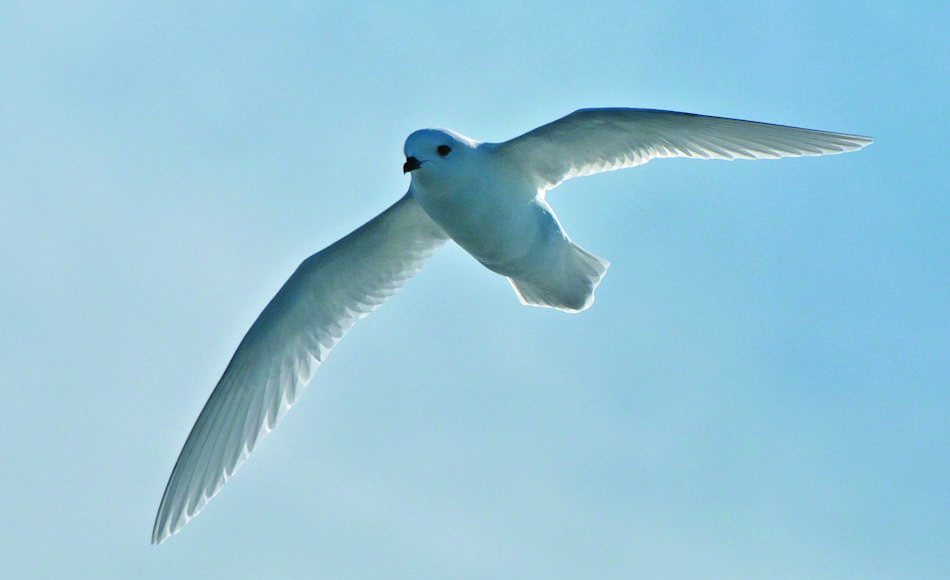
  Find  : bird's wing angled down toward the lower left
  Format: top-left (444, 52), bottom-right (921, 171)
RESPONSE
top-left (152, 191), bottom-right (448, 543)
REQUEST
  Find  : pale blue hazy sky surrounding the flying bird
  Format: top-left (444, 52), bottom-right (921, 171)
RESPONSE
top-left (0, 0), bottom-right (950, 580)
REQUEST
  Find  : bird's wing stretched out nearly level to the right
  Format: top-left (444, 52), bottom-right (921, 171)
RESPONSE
top-left (496, 109), bottom-right (872, 190)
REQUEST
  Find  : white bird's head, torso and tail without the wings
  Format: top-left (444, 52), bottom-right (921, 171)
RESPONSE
top-left (405, 129), bottom-right (608, 311)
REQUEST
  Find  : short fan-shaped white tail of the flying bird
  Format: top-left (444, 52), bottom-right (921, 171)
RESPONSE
top-left (508, 242), bottom-right (610, 312)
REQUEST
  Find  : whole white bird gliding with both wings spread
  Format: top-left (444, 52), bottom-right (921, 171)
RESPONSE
top-left (152, 109), bottom-right (872, 544)
